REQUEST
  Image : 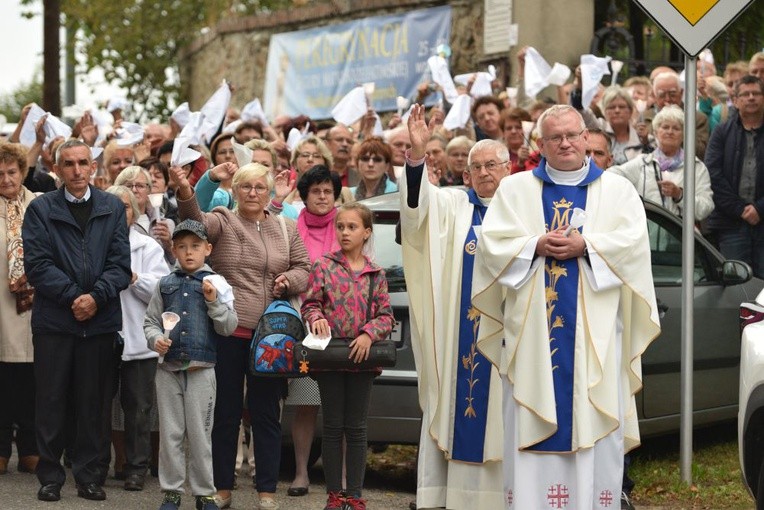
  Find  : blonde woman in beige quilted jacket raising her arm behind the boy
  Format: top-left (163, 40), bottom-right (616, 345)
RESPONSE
top-left (170, 163), bottom-right (310, 509)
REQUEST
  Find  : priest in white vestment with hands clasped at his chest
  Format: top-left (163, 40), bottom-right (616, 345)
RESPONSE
top-left (472, 105), bottom-right (660, 510)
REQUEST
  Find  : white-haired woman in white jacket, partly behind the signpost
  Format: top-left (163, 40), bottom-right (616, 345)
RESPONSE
top-left (608, 105), bottom-right (714, 221)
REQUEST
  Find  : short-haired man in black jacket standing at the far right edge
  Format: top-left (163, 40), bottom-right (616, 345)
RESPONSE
top-left (706, 75), bottom-right (764, 278)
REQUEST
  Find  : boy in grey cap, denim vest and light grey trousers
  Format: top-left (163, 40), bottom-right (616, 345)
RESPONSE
top-left (143, 220), bottom-right (238, 510)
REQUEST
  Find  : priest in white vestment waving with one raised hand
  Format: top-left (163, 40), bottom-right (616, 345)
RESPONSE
top-left (399, 105), bottom-right (509, 510)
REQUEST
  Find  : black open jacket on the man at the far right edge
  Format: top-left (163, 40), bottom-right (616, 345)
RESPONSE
top-left (705, 110), bottom-right (764, 230)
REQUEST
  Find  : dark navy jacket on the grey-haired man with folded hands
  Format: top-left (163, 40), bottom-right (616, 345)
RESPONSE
top-left (22, 186), bottom-right (132, 337)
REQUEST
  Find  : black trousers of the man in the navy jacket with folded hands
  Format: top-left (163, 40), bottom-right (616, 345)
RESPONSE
top-left (32, 332), bottom-right (116, 485)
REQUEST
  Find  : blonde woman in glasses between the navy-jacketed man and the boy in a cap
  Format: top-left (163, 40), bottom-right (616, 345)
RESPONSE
top-left (114, 165), bottom-right (175, 266)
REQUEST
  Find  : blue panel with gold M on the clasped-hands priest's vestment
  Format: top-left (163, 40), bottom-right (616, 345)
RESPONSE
top-left (529, 160), bottom-right (602, 452)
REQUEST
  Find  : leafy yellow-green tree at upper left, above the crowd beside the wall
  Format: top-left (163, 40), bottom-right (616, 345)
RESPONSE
top-left (20, 0), bottom-right (291, 120)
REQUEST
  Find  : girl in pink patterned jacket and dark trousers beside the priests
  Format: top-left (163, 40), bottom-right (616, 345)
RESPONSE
top-left (302, 203), bottom-right (394, 510)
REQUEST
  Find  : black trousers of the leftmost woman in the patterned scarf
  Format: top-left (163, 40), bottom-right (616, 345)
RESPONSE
top-left (0, 363), bottom-right (37, 459)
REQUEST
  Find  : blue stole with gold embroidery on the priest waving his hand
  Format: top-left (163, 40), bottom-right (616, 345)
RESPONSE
top-left (451, 189), bottom-right (491, 462)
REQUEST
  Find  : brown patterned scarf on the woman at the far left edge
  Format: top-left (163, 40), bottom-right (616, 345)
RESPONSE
top-left (3, 187), bottom-right (34, 313)
